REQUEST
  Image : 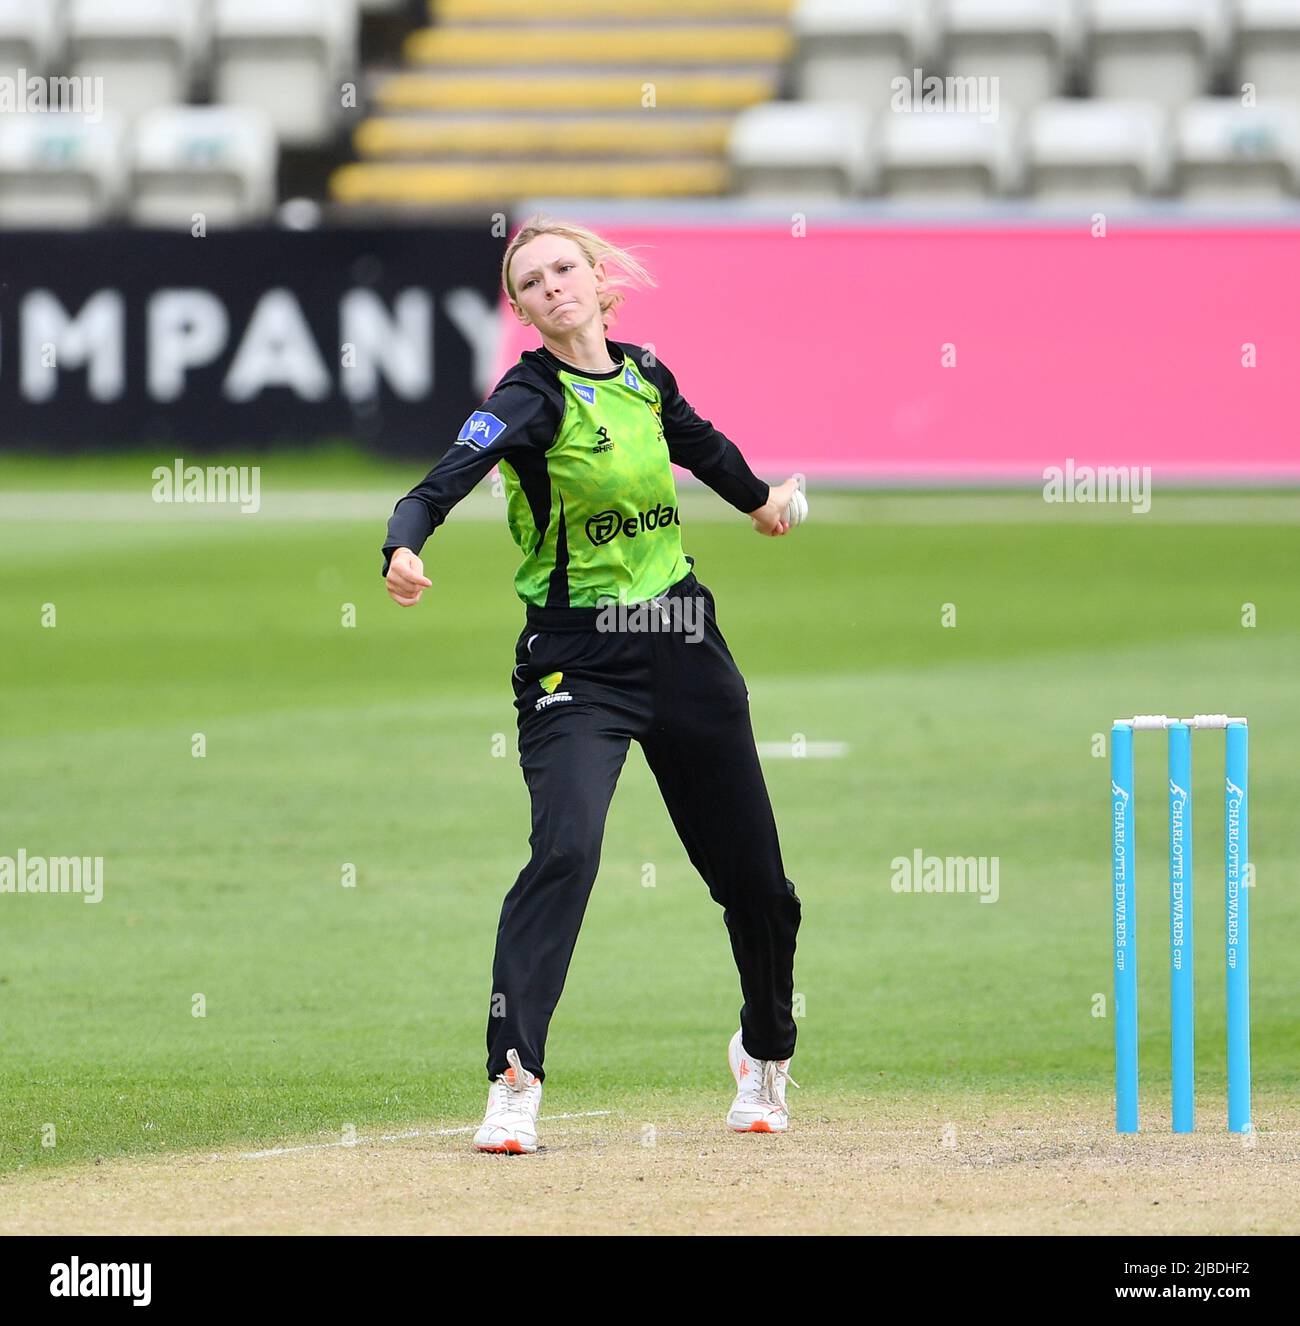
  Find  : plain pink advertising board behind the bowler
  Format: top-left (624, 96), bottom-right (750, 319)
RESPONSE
top-left (499, 223), bottom-right (1300, 484)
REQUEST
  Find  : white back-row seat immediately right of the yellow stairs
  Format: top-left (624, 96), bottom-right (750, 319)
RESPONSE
top-left (792, 0), bottom-right (934, 110)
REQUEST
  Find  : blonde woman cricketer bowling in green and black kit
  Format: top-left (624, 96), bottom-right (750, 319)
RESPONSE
top-left (383, 216), bottom-right (807, 1154)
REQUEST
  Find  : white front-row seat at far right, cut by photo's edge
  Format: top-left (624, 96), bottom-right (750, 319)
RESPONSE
top-left (1175, 97), bottom-right (1300, 202)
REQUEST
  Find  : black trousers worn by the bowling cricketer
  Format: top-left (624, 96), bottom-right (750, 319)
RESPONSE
top-left (487, 573), bottom-right (800, 1078)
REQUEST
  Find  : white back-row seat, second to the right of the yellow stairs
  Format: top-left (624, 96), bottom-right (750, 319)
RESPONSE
top-left (939, 0), bottom-right (1080, 109)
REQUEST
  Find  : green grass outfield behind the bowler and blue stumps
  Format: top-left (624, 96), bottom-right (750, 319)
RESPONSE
top-left (0, 452), bottom-right (1300, 1170)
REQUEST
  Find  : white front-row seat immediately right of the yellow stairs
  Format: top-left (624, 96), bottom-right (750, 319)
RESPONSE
top-left (728, 101), bottom-right (877, 199)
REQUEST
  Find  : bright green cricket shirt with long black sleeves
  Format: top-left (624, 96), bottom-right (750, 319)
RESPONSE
top-left (383, 341), bottom-right (768, 607)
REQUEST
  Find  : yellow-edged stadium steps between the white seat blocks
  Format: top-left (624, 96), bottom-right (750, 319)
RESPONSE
top-left (330, 0), bottom-right (793, 210)
